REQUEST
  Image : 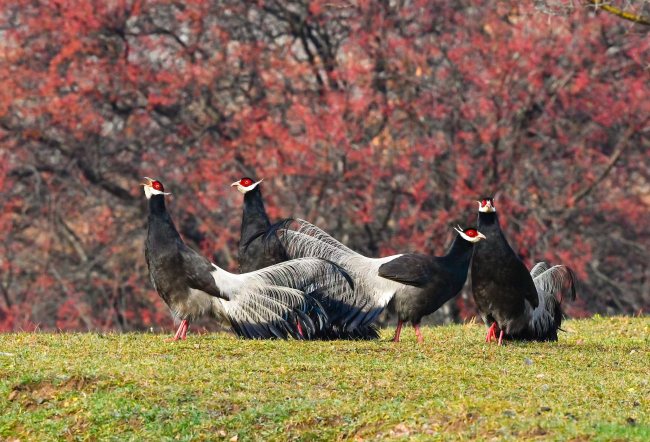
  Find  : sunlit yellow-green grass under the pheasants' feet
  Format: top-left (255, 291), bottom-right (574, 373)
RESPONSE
top-left (0, 317), bottom-right (650, 441)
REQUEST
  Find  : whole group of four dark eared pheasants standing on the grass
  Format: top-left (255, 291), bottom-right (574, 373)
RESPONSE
top-left (142, 178), bottom-right (576, 345)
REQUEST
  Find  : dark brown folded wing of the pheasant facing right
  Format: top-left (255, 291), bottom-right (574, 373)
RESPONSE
top-left (379, 253), bottom-right (443, 287)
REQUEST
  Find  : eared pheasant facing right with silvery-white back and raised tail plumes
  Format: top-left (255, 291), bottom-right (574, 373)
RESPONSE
top-left (279, 219), bottom-right (485, 342)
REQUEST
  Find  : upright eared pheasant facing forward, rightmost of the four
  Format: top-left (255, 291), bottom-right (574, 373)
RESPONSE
top-left (471, 197), bottom-right (576, 345)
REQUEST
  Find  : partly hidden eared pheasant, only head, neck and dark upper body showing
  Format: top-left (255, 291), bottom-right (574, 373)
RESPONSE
top-left (231, 177), bottom-right (289, 273)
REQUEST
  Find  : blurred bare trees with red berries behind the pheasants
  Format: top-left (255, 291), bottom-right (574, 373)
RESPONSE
top-left (0, 0), bottom-right (650, 331)
